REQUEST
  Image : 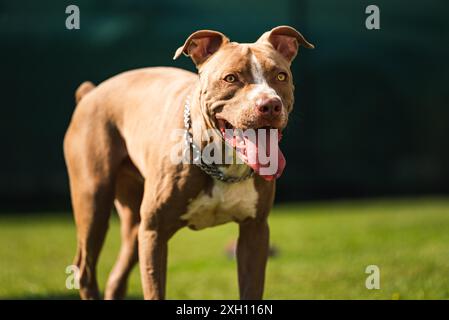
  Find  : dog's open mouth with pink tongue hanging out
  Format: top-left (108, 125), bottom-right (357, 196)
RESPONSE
top-left (217, 119), bottom-right (286, 181)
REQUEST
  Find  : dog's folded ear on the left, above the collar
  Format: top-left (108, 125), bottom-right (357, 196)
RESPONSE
top-left (173, 30), bottom-right (229, 67)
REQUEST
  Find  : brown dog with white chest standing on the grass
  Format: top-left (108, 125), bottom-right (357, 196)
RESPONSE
top-left (64, 26), bottom-right (313, 299)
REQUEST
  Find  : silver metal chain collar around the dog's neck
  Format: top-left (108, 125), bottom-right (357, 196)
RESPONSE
top-left (184, 96), bottom-right (254, 183)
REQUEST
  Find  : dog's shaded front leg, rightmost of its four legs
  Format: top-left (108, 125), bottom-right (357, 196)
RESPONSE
top-left (237, 218), bottom-right (269, 300)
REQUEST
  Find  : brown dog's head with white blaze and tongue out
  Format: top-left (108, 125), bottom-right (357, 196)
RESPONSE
top-left (174, 26), bottom-right (314, 180)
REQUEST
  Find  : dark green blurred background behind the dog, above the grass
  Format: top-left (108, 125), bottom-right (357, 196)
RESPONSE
top-left (0, 0), bottom-right (449, 211)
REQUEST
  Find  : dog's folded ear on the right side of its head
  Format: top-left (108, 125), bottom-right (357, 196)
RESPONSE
top-left (257, 26), bottom-right (315, 62)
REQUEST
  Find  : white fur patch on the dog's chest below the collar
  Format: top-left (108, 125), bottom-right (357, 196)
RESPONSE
top-left (181, 179), bottom-right (258, 230)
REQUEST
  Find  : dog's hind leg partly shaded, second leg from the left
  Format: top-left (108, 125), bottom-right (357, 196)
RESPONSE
top-left (105, 162), bottom-right (143, 300)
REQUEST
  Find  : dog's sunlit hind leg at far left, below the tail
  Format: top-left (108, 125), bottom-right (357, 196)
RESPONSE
top-left (64, 99), bottom-right (126, 299)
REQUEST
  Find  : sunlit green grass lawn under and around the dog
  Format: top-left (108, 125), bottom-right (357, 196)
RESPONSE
top-left (0, 199), bottom-right (449, 299)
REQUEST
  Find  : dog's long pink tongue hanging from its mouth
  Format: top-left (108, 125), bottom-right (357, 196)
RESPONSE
top-left (244, 129), bottom-right (286, 181)
